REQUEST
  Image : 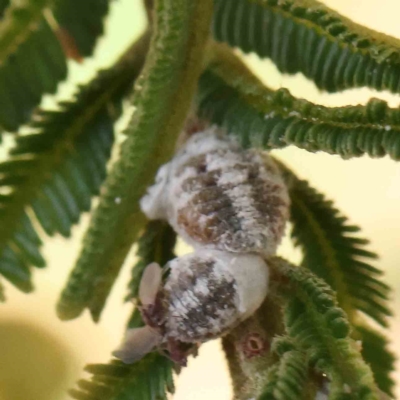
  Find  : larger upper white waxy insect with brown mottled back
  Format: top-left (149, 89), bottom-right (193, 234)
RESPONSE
top-left (141, 127), bottom-right (289, 256)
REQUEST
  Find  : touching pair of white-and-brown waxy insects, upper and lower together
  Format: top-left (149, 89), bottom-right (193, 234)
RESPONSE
top-left (114, 128), bottom-right (289, 365)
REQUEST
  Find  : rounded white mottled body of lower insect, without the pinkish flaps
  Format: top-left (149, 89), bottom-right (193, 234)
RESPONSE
top-left (165, 250), bottom-right (268, 342)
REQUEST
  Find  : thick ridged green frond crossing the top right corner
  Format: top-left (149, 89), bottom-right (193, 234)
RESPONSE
top-left (213, 0), bottom-right (400, 93)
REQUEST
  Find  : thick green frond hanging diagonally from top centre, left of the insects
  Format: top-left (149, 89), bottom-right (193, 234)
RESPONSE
top-left (57, 0), bottom-right (212, 321)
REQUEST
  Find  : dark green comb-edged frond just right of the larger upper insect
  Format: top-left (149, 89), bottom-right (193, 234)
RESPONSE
top-left (284, 164), bottom-right (391, 326)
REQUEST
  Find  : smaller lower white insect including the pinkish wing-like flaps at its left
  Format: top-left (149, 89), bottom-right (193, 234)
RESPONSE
top-left (113, 249), bottom-right (269, 365)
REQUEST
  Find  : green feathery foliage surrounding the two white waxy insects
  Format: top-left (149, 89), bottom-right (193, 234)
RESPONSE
top-left (0, 0), bottom-right (400, 400)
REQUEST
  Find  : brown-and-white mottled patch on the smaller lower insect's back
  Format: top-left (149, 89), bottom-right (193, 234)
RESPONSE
top-left (165, 254), bottom-right (238, 342)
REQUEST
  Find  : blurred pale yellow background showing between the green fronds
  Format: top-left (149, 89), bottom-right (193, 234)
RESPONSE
top-left (0, 0), bottom-right (400, 400)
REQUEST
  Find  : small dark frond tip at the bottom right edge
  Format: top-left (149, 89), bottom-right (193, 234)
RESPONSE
top-left (354, 325), bottom-right (396, 397)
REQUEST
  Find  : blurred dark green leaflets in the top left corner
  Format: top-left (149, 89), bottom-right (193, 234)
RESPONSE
top-left (0, 0), bottom-right (108, 131)
